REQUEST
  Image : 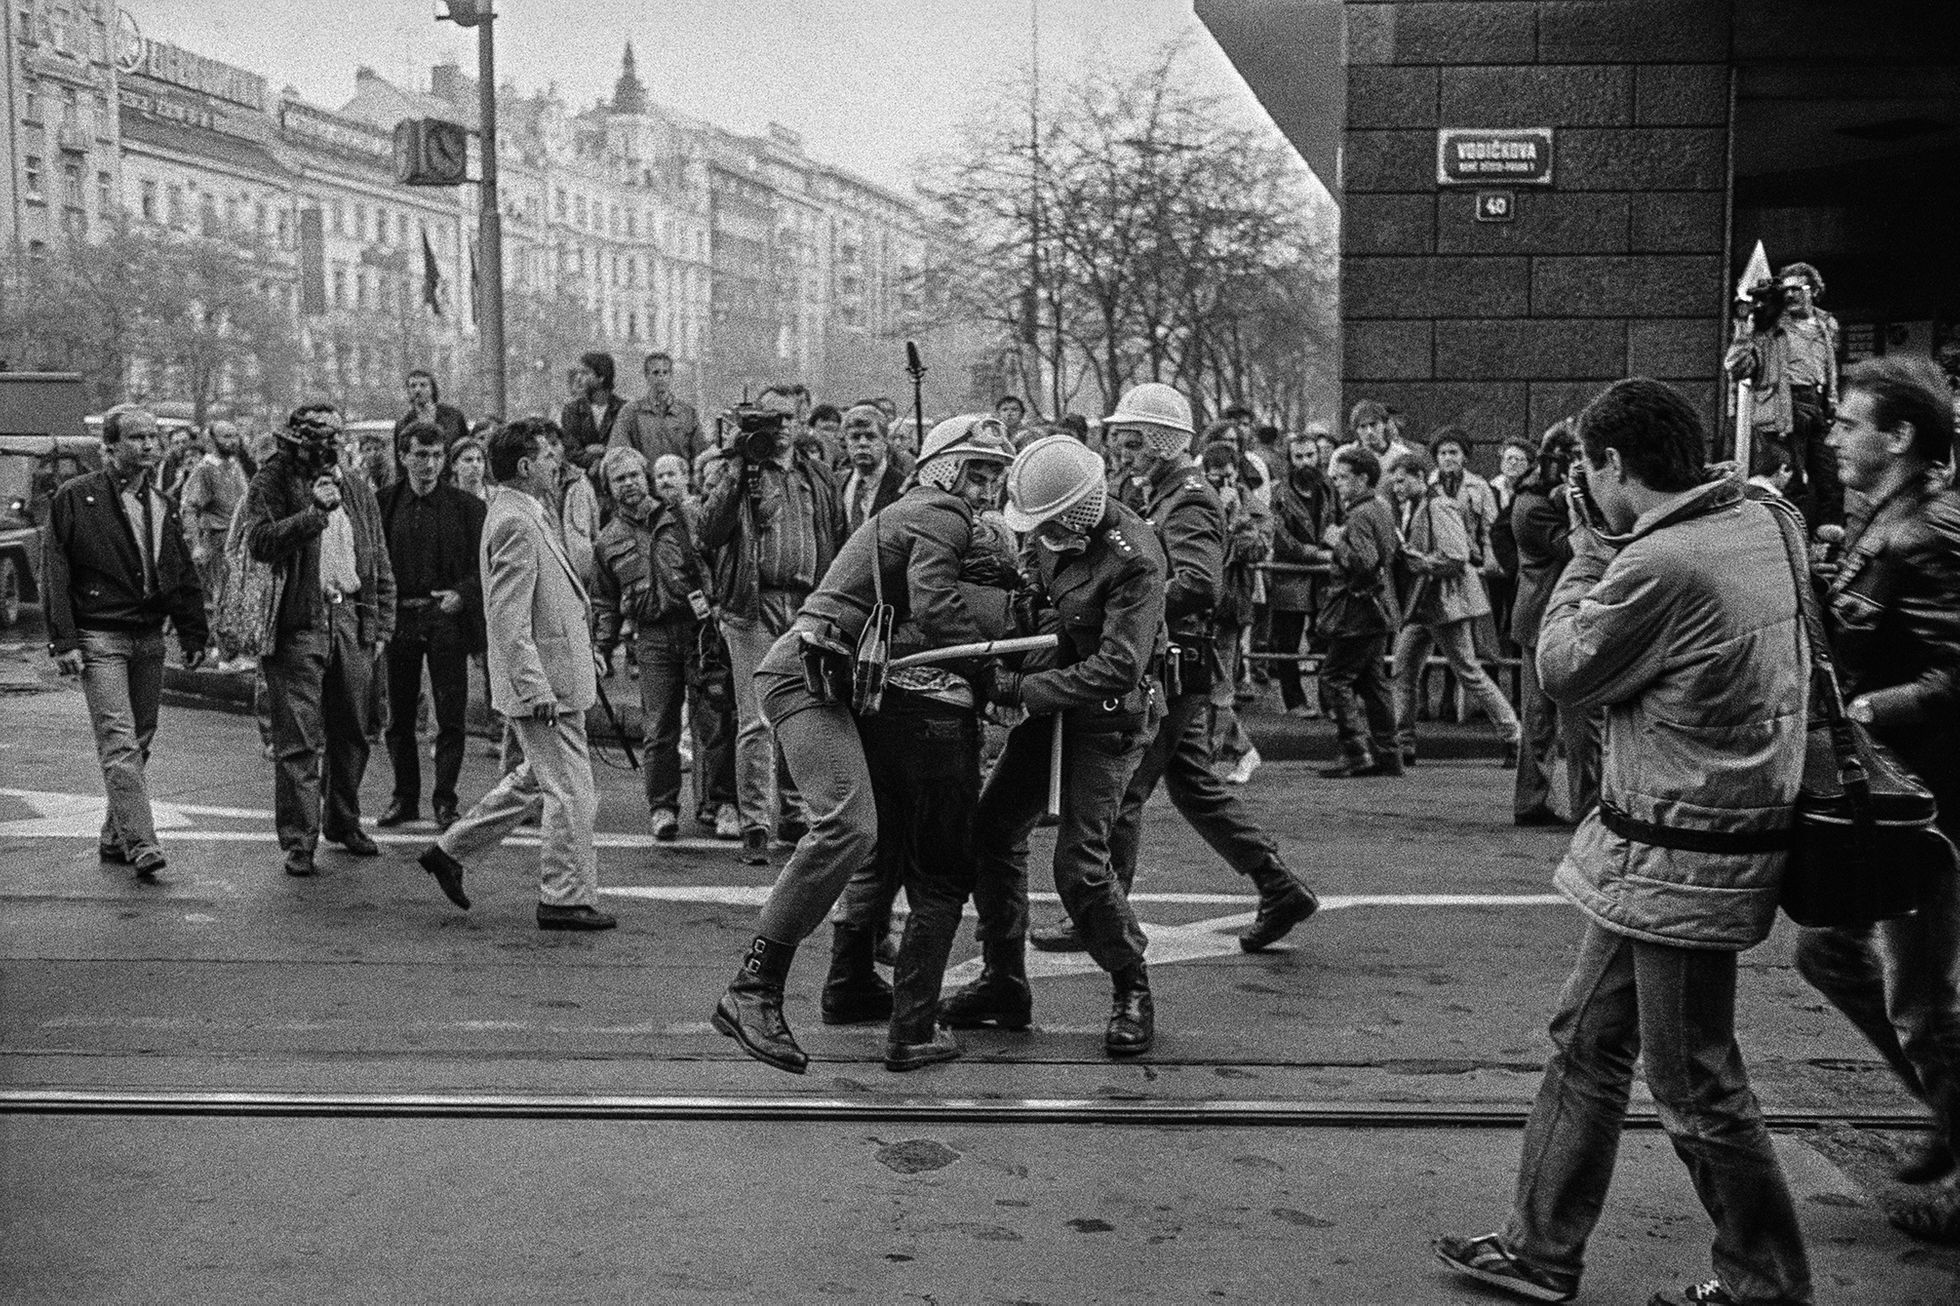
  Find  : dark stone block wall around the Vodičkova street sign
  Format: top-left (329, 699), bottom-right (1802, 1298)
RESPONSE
top-left (1341, 0), bottom-right (1731, 456)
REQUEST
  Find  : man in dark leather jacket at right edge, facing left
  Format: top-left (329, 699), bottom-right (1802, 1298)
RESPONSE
top-left (1797, 355), bottom-right (1960, 1237)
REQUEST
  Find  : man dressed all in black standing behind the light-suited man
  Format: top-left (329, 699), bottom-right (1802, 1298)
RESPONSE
top-left (374, 422), bottom-right (484, 829)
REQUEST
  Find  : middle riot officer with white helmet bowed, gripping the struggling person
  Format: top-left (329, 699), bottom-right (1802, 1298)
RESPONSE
top-left (941, 435), bottom-right (1164, 1057)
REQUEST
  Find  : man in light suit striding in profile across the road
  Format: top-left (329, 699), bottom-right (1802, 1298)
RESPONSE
top-left (419, 418), bottom-right (619, 929)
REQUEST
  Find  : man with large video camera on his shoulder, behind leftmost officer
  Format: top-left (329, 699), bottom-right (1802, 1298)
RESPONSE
top-left (700, 386), bottom-right (845, 865)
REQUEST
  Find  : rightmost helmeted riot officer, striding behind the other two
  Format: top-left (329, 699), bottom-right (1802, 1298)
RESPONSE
top-left (1033, 380), bottom-right (1319, 953)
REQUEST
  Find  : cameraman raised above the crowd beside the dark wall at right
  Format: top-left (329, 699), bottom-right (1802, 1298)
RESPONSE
top-left (1723, 263), bottom-right (1844, 529)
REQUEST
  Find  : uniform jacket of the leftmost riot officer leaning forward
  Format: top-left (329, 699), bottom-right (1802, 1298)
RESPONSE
top-left (800, 484), bottom-right (986, 657)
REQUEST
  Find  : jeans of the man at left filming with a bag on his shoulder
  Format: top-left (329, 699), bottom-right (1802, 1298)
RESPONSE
top-left (259, 602), bottom-right (372, 853)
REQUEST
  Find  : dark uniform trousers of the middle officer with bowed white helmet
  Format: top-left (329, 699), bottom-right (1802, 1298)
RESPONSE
top-left (974, 696), bottom-right (1144, 973)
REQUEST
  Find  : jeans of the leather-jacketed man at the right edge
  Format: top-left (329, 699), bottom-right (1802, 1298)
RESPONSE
top-left (1797, 854), bottom-right (1960, 1143)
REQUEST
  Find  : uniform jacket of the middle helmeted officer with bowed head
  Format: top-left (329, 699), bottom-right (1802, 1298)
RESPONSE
top-left (1021, 498), bottom-right (1160, 722)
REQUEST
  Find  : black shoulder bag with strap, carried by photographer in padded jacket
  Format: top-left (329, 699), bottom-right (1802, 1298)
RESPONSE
top-left (1768, 494), bottom-right (1956, 926)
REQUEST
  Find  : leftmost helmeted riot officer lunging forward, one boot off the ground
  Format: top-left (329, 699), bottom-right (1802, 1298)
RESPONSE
top-left (713, 420), bottom-right (1013, 1075)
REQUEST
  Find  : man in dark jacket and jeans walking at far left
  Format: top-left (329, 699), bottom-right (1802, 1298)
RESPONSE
top-left (41, 406), bottom-right (206, 880)
